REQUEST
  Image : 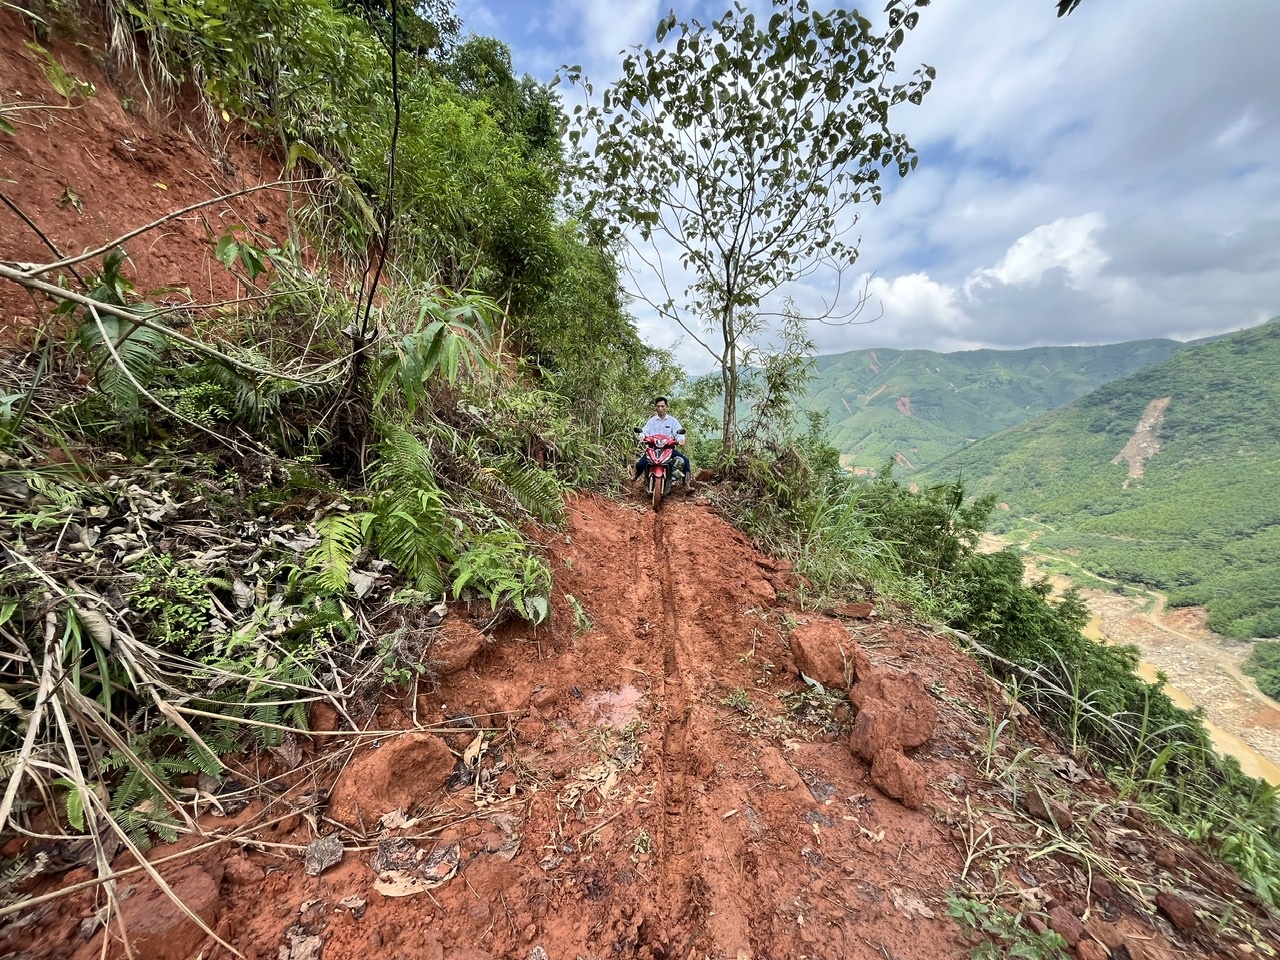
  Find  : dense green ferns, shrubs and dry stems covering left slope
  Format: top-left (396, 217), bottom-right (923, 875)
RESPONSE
top-left (0, 0), bottom-right (680, 870)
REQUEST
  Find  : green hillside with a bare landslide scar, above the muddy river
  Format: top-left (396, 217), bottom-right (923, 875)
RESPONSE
top-left (923, 319), bottom-right (1280, 637)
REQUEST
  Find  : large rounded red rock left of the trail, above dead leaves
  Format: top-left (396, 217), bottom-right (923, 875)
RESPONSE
top-left (329, 732), bottom-right (454, 827)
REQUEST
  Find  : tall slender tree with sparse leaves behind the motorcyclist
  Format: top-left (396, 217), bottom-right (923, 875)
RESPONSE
top-left (566, 0), bottom-right (934, 454)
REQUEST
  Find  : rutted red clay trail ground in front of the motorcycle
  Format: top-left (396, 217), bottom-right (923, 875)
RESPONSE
top-left (0, 497), bottom-right (1280, 960)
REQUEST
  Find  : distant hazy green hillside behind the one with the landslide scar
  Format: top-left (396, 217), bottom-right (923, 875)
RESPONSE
top-left (803, 340), bottom-right (1187, 470)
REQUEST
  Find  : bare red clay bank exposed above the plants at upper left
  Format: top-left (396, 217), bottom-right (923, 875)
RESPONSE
top-left (0, 8), bottom-right (287, 347)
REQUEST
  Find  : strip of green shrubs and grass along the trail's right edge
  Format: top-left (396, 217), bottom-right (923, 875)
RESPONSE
top-left (721, 419), bottom-right (1280, 911)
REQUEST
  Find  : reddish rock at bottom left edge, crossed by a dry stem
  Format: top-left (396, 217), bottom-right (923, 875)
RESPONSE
top-left (93, 861), bottom-right (223, 960)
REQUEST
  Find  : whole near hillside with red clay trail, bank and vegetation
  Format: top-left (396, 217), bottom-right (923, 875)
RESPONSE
top-left (0, 0), bottom-right (1280, 960)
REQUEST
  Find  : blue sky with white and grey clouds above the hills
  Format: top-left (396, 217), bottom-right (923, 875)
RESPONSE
top-left (457, 0), bottom-right (1280, 372)
